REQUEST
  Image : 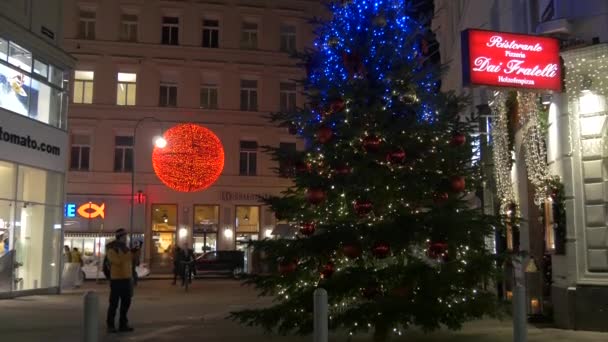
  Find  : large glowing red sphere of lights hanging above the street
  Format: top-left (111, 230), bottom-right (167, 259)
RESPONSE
top-left (152, 123), bottom-right (224, 192)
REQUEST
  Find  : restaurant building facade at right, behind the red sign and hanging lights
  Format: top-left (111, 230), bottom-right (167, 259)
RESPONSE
top-left (435, 0), bottom-right (608, 330)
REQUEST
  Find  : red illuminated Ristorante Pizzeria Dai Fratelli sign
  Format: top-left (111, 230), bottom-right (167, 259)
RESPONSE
top-left (461, 29), bottom-right (562, 91)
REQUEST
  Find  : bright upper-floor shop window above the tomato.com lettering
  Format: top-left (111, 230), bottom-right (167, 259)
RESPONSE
top-left (0, 38), bottom-right (67, 129)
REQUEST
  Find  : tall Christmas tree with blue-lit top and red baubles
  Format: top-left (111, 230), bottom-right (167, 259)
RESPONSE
top-left (232, 0), bottom-right (498, 340)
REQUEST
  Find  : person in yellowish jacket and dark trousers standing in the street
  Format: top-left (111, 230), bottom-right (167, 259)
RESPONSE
top-left (106, 228), bottom-right (133, 333)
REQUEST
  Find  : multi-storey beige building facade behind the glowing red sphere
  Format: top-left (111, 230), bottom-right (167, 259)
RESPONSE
top-left (63, 0), bottom-right (322, 272)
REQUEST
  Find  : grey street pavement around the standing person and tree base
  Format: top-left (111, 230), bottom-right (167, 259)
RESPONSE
top-left (0, 279), bottom-right (608, 342)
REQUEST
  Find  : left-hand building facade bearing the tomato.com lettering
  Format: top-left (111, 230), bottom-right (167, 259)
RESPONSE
top-left (0, 0), bottom-right (74, 298)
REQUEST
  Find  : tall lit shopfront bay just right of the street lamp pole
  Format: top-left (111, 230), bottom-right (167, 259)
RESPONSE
top-left (151, 204), bottom-right (177, 269)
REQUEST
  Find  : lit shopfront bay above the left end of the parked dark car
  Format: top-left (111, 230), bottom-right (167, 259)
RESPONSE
top-left (192, 205), bottom-right (220, 254)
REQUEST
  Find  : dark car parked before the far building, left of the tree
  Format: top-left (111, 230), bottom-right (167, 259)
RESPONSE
top-left (195, 251), bottom-right (245, 277)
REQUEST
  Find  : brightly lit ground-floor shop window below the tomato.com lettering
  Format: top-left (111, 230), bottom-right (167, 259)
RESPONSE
top-left (0, 161), bottom-right (64, 291)
